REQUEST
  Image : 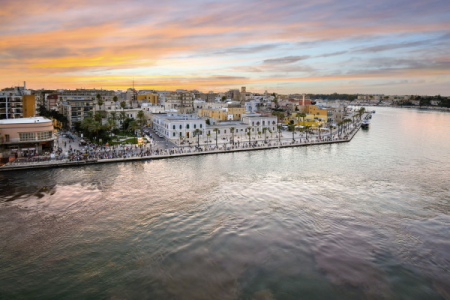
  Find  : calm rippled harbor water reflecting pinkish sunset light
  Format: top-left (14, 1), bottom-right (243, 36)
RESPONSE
top-left (0, 108), bottom-right (450, 300)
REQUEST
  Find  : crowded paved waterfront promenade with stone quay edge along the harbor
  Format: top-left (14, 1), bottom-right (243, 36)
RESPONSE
top-left (0, 115), bottom-right (368, 172)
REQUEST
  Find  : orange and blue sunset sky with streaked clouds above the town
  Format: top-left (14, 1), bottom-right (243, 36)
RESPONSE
top-left (0, 0), bottom-right (450, 95)
